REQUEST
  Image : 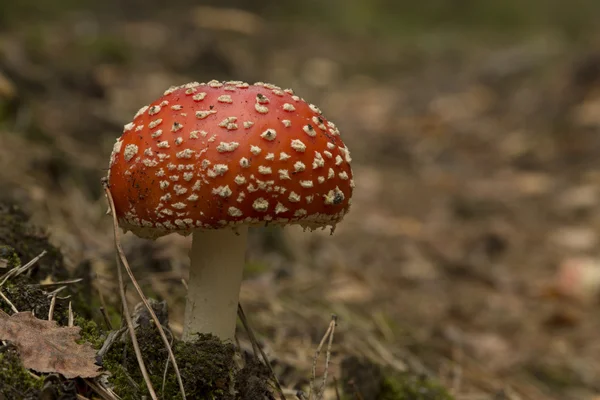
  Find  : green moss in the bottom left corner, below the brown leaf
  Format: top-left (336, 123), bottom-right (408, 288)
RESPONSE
top-left (0, 346), bottom-right (42, 399)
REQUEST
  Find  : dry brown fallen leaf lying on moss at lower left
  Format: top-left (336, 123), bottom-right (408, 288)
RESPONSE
top-left (0, 311), bottom-right (100, 379)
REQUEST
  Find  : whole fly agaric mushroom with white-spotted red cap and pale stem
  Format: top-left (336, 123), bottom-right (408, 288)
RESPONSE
top-left (108, 81), bottom-right (354, 340)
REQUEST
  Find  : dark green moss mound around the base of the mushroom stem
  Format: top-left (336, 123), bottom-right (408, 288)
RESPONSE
top-left (102, 324), bottom-right (270, 400)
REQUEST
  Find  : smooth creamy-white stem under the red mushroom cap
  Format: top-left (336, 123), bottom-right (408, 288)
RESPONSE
top-left (183, 226), bottom-right (248, 341)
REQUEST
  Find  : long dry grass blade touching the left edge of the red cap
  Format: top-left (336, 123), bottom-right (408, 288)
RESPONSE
top-left (102, 180), bottom-right (186, 400)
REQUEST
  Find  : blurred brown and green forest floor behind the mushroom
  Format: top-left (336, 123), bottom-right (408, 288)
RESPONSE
top-left (0, 0), bottom-right (600, 400)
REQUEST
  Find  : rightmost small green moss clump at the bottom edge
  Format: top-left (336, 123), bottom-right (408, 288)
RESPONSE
top-left (377, 373), bottom-right (453, 400)
